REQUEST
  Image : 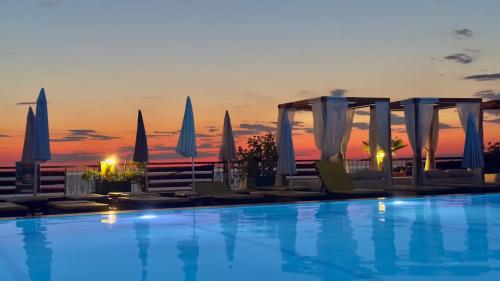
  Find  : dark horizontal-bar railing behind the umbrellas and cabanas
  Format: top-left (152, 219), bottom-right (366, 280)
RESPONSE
top-left (0, 157), bottom-right (462, 197)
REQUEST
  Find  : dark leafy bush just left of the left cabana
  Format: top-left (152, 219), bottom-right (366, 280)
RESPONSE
top-left (236, 132), bottom-right (278, 187)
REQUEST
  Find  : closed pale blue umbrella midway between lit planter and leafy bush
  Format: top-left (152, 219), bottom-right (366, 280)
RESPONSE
top-left (175, 97), bottom-right (197, 188)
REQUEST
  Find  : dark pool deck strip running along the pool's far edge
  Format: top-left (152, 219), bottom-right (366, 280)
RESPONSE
top-left (0, 183), bottom-right (500, 219)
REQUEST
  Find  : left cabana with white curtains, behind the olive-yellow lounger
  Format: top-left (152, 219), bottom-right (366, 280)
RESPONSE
top-left (276, 96), bottom-right (392, 187)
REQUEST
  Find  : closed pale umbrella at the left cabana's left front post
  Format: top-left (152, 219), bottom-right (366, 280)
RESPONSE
top-left (277, 110), bottom-right (297, 189)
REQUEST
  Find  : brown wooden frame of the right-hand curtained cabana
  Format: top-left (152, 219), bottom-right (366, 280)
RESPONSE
top-left (390, 98), bottom-right (484, 185)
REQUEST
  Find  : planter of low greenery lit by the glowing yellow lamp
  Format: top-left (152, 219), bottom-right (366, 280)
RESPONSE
top-left (82, 161), bottom-right (143, 194)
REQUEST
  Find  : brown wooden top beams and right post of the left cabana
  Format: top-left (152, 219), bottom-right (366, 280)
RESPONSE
top-left (278, 96), bottom-right (392, 183)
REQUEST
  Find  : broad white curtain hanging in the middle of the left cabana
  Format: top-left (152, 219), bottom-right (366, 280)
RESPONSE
top-left (311, 97), bottom-right (348, 160)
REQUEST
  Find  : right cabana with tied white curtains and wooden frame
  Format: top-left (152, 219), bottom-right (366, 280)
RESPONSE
top-left (391, 98), bottom-right (484, 185)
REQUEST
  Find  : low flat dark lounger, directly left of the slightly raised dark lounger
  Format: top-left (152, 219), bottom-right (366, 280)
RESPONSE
top-left (116, 195), bottom-right (191, 209)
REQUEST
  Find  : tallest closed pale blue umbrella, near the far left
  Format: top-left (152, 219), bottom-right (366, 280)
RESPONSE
top-left (33, 88), bottom-right (50, 197)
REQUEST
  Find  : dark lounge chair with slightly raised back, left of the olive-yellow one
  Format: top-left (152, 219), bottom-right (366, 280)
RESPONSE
top-left (194, 182), bottom-right (264, 203)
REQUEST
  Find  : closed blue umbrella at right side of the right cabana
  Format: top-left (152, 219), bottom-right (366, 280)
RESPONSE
top-left (462, 113), bottom-right (484, 169)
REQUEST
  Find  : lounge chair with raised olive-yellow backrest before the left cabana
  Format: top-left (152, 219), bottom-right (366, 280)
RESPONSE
top-left (315, 161), bottom-right (387, 197)
